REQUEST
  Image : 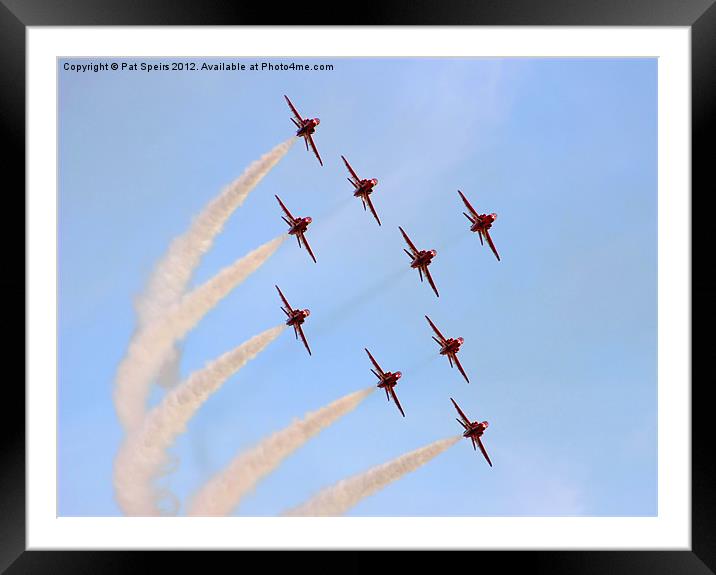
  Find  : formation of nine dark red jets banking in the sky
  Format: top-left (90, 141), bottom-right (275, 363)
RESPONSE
top-left (276, 96), bottom-right (500, 467)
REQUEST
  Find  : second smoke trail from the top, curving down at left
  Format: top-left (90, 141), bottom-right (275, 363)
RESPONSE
top-left (114, 235), bottom-right (287, 430)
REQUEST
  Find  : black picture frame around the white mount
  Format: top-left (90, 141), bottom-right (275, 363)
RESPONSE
top-left (5, 0), bottom-right (716, 574)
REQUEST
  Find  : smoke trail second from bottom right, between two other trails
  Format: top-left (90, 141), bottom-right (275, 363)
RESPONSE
top-left (187, 387), bottom-right (376, 516)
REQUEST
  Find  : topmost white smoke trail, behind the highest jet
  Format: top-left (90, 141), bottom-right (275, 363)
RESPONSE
top-left (136, 137), bottom-right (296, 328)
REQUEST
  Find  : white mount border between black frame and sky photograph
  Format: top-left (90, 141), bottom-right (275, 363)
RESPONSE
top-left (27, 27), bottom-right (691, 549)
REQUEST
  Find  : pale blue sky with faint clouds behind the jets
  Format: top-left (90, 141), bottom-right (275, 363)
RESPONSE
top-left (58, 59), bottom-right (657, 516)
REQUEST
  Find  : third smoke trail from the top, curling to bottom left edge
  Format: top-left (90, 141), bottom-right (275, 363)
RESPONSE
top-left (114, 325), bottom-right (286, 516)
